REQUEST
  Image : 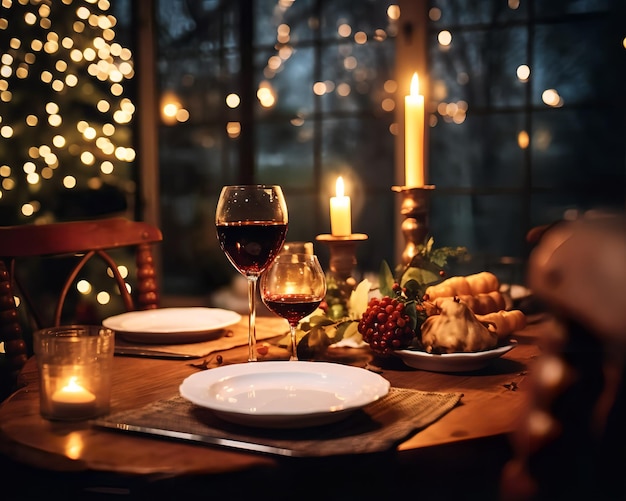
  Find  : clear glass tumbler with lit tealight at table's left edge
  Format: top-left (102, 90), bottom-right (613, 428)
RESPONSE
top-left (33, 325), bottom-right (115, 420)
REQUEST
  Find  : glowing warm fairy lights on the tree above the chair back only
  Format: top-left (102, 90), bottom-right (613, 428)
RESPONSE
top-left (0, 0), bottom-right (135, 219)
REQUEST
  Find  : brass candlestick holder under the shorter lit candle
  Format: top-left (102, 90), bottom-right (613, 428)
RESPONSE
top-left (315, 233), bottom-right (368, 318)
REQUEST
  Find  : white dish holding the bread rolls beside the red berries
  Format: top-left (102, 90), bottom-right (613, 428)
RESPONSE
top-left (394, 343), bottom-right (515, 372)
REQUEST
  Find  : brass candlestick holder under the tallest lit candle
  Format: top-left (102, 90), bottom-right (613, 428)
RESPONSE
top-left (391, 184), bottom-right (435, 266)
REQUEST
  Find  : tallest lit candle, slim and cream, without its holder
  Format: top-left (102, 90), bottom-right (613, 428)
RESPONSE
top-left (404, 73), bottom-right (424, 188)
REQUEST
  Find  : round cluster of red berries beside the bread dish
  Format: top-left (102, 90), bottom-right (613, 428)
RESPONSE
top-left (358, 296), bottom-right (415, 355)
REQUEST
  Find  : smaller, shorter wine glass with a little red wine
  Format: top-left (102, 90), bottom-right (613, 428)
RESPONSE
top-left (261, 253), bottom-right (326, 360)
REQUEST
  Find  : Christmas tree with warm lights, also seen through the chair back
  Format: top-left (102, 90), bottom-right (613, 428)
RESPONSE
top-left (0, 0), bottom-right (137, 322)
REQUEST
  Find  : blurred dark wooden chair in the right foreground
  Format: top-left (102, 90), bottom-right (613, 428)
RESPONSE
top-left (500, 211), bottom-right (626, 501)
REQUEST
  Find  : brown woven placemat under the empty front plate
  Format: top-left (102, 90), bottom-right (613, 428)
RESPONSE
top-left (93, 388), bottom-right (463, 457)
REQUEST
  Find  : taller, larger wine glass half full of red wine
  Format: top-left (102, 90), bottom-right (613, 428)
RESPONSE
top-left (215, 185), bottom-right (289, 362)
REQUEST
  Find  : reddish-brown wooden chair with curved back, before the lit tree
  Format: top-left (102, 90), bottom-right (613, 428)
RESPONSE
top-left (0, 217), bottom-right (163, 401)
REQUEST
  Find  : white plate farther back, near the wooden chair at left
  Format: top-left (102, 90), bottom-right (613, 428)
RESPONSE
top-left (102, 306), bottom-right (241, 344)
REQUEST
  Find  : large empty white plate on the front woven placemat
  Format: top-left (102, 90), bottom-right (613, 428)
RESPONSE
top-left (180, 360), bottom-right (390, 428)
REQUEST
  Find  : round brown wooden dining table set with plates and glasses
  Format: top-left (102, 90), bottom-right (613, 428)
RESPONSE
top-left (0, 317), bottom-right (551, 499)
